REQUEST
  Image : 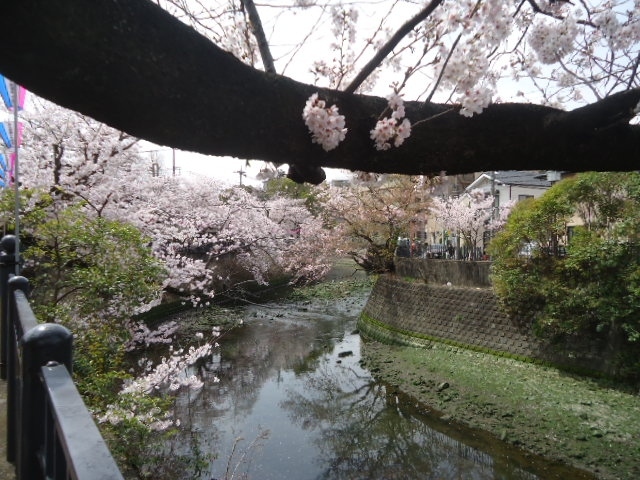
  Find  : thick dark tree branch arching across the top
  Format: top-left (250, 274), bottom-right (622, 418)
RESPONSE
top-left (0, 0), bottom-right (640, 181)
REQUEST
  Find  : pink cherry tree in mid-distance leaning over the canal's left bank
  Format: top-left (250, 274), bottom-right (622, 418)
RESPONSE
top-left (133, 178), bottom-right (334, 302)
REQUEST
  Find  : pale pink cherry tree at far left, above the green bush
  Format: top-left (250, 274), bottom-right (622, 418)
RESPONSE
top-left (20, 97), bottom-right (150, 218)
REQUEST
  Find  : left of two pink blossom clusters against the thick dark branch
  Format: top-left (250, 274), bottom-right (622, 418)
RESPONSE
top-left (302, 93), bottom-right (347, 152)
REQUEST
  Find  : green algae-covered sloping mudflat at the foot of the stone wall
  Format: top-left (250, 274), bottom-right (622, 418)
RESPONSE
top-left (362, 341), bottom-right (640, 480)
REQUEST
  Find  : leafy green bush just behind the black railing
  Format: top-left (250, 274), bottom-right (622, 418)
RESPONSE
top-left (23, 199), bottom-right (166, 322)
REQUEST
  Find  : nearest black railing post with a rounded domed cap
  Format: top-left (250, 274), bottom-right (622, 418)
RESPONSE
top-left (16, 323), bottom-right (73, 479)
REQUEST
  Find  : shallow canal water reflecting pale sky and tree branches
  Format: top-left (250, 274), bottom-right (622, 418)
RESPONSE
top-left (172, 294), bottom-right (592, 480)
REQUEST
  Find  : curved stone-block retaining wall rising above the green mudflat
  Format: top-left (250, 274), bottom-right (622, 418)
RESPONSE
top-left (359, 276), bottom-right (615, 374)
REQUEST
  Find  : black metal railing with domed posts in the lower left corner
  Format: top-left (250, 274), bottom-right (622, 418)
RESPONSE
top-left (0, 235), bottom-right (123, 480)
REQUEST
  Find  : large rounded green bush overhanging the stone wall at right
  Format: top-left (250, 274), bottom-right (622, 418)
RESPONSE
top-left (491, 172), bottom-right (640, 352)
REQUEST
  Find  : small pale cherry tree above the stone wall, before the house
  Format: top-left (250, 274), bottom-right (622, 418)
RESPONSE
top-left (429, 190), bottom-right (513, 260)
